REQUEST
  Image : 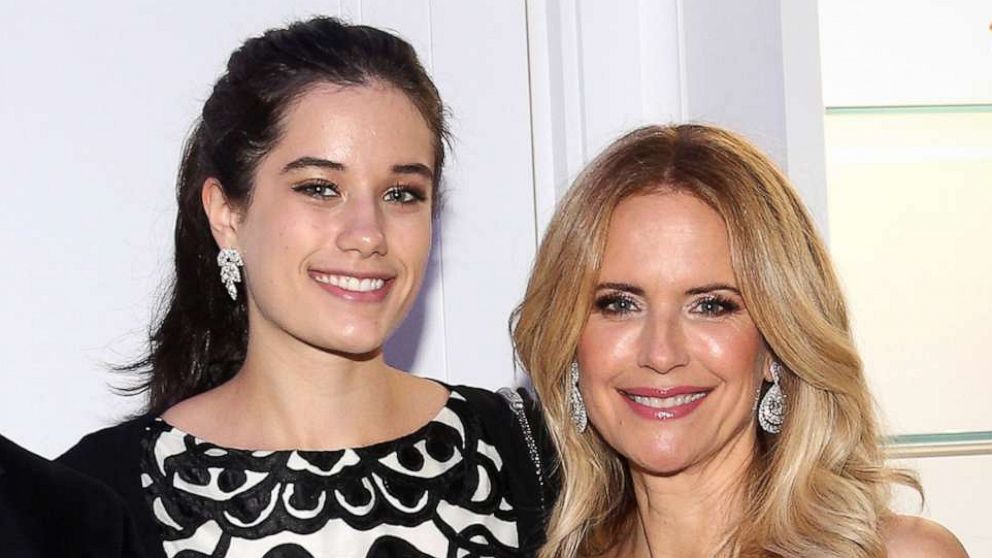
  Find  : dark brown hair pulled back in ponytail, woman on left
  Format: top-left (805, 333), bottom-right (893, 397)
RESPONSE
top-left (122, 17), bottom-right (449, 414)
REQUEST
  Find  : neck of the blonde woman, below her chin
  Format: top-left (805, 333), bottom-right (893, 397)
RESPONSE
top-left (625, 426), bottom-right (754, 558)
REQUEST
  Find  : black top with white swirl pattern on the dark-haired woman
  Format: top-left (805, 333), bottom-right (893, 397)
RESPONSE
top-left (60, 387), bottom-right (555, 558)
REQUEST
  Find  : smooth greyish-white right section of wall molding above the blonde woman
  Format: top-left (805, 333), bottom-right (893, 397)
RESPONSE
top-left (681, 0), bottom-right (827, 234)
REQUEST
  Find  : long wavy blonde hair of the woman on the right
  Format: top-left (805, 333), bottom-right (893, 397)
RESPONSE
top-left (512, 125), bottom-right (920, 558)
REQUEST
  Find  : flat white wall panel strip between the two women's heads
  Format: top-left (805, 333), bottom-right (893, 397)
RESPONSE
top-left (431, 0), bottom-right (536, 387)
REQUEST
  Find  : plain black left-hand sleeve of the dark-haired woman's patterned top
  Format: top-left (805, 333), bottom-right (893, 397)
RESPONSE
top-left (56, 416), bottom-right (165, 558)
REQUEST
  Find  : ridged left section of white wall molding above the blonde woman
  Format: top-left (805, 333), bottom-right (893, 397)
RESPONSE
top-left (527, 0), bottom-right (684, 231)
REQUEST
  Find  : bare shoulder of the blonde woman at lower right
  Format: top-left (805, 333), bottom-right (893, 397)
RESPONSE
top-left (882, 515), bottom-right (968, 558)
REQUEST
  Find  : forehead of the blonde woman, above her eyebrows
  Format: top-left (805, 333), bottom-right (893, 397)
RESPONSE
top-left (603, 191), bottom-right (734, 284)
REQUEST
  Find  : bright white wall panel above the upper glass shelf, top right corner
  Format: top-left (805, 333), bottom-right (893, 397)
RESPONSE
top-left (820, 0), bottom-right (992, 107)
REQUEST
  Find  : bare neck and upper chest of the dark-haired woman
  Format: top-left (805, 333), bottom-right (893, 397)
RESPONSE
top-left (163, 318), bottom-right (447, 450)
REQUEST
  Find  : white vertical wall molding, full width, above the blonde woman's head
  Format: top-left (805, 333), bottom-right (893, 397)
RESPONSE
top-left (527, 0), bottom-right (827, 232)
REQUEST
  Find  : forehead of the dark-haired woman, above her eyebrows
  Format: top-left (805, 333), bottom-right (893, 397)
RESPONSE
top-left (272, 83), bottom-right (434, 168)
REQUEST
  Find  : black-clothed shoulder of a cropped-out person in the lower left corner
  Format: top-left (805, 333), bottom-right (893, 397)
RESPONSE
top-left (0, 436), bottom-right (146, 558)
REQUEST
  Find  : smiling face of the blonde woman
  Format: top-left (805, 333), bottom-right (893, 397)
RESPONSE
top-left (578, 191), bottom-right (767, 474)
